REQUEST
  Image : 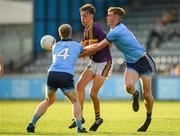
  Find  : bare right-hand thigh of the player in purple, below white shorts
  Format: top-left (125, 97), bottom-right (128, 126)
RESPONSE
top-left (91, 74), bottom-right (106, 95)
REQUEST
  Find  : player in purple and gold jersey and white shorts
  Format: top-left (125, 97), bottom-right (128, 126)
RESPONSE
top-left (69, 4), bottom-right (112, 131)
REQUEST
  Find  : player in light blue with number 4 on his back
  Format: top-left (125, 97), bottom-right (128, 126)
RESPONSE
top-left (27, 24), bottom-right (87, 133)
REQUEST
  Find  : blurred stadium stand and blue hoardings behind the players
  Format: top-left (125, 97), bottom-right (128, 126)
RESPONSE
top-left (0, 0), bottom-right (180, 100)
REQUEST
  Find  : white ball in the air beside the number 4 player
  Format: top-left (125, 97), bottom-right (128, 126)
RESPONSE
top-left (41, 35), bottom-right (56, 51)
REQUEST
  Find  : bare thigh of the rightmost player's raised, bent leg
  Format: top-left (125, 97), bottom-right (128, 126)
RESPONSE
top-left (124, 69), bottom-right (139, 86)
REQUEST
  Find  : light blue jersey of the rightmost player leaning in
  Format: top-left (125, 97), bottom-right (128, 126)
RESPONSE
top-left (106, 23), bottom-right (145, 63)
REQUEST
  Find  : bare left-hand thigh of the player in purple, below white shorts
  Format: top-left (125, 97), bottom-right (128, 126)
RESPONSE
top-left (77, 68), bottom-right (94, 87)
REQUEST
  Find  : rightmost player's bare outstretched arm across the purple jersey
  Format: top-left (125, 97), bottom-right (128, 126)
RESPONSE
top-left (84, 39), bottom-right (111, 52)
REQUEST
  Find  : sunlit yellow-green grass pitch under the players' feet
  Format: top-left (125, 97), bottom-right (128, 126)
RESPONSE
top-left (0, 101), bottom-right (180, 136)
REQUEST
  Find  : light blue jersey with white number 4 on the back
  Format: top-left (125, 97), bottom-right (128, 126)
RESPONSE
top-left (48, 40), bottom-right (83, 75)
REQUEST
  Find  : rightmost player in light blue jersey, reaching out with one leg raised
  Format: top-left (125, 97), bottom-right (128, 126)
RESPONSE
top-left (85, 7), bottom-right (155, 131)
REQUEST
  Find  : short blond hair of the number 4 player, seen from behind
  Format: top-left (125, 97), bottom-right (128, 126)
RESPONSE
top-left (58, 24), bottom-right (72, 38)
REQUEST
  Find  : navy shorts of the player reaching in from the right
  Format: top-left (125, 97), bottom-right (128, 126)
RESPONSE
top-left (125, 53), bottom-right (156, 76)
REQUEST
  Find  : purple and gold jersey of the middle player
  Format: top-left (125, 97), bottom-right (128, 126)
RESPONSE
top-left (82, 23), bottom-right (112, 63)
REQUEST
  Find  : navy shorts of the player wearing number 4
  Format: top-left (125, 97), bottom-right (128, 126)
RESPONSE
top-left (47, 71), bottom-right (74, 93)
